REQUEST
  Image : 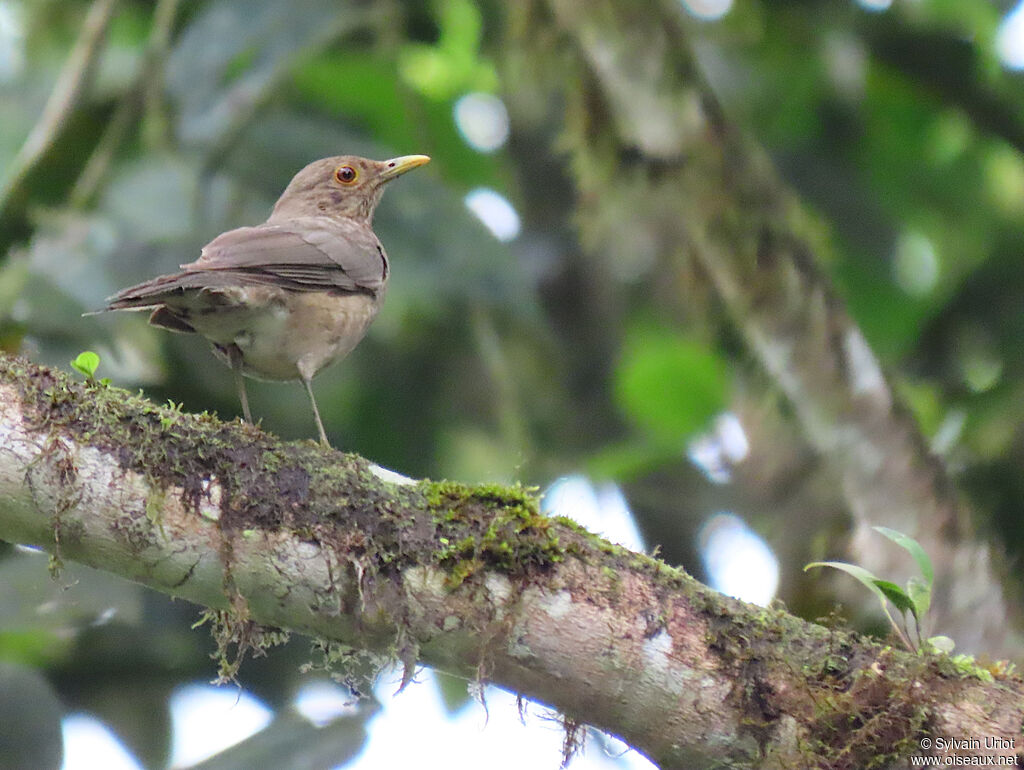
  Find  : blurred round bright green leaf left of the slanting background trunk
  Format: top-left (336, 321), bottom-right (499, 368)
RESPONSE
top-left (614, 331), bottom-right (727, 445)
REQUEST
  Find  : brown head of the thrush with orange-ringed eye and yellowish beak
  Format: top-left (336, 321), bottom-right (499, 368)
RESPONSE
top-left (270, 155), bottom-right (430, 222)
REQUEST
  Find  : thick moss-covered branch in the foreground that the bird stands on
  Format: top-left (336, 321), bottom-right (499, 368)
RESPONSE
top-left (0, 357), bottom-right (1024, 768)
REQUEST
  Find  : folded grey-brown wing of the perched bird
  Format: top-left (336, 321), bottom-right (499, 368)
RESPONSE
top-left (181, 217), bottom-right (388, 292)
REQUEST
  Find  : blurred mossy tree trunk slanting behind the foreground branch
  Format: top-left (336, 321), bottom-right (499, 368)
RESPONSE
top-left (505, 0), bottom-right (1024, 656)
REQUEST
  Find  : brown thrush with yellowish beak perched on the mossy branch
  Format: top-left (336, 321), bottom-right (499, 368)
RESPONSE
top-left (103, 155), bottom-right (430, 445)
